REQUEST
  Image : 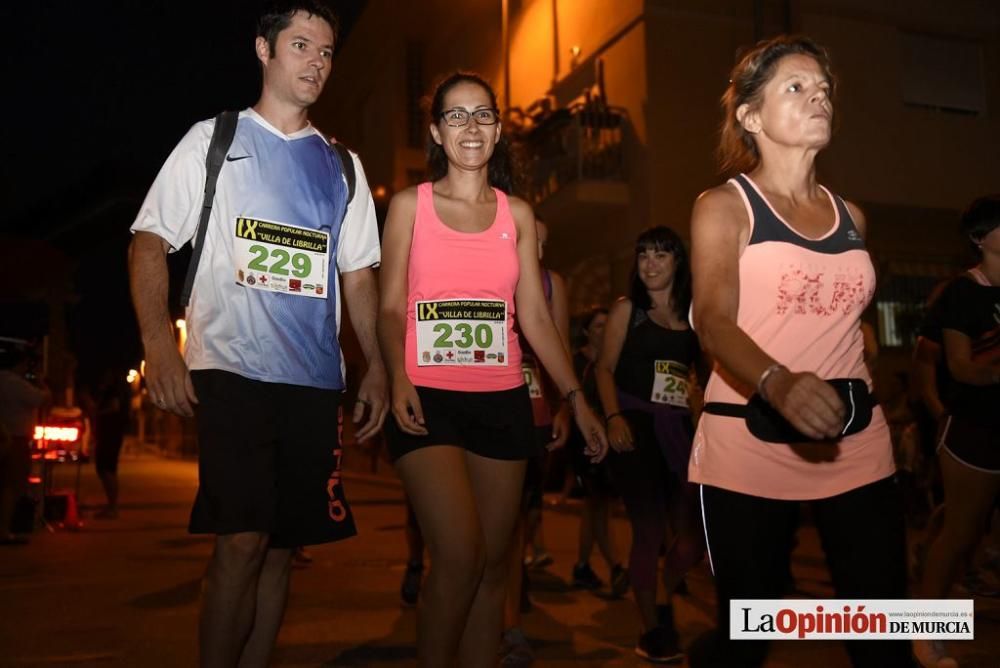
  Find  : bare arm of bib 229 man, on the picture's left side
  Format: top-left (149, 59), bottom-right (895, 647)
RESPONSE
top-left (128, 232), bottom-right (198, 417)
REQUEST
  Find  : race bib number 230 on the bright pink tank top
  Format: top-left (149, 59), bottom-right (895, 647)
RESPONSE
top-left (414, 299), bottom-right (507, 366)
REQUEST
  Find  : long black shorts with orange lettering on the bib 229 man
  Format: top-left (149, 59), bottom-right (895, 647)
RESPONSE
top-left (189, 370), bottom-right (357, 548)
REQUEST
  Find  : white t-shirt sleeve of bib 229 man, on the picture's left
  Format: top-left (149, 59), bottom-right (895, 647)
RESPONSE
top-left (131, 119), bottom-right (215, 252)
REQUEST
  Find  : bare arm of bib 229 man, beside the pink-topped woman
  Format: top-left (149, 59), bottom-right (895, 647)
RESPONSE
top-left (341, 267), bottom-right (389, 442)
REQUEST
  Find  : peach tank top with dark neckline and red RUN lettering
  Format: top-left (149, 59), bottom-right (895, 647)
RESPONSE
top-left (688, 175), bottom-right (895, 500)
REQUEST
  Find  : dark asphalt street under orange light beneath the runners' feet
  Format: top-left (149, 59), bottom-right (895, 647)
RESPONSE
top-left (0, 452), bottom-right (1000, 668)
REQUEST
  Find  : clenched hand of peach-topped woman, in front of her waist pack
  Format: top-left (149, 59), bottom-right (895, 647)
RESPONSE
top-left (761, 368), bottom-right (846, 441)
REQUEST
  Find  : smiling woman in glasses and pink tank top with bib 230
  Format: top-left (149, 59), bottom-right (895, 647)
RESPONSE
top-left (378, 73), bottom-right (607, 666)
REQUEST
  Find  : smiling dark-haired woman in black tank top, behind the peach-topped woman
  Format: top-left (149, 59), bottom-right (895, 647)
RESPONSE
top-left (595, 226), bottom-right (704, 661)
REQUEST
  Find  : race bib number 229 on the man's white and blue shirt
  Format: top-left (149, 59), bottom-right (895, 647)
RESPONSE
top-left (233, 217), bottom-right (330, 299)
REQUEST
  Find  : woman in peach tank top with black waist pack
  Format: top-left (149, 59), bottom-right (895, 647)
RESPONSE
top-left (689, 36), bottom-right (912, 668)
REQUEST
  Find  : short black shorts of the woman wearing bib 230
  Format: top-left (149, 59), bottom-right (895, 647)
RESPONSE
top-left (385, 385), bottom-right (540, 461)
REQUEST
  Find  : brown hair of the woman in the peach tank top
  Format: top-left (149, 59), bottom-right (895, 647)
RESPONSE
top-left (717, 35), bottom-right (837, 175)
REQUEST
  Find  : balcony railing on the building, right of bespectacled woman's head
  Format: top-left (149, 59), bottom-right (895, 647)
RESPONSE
top-left (516, 103), bottom-right (628, 205)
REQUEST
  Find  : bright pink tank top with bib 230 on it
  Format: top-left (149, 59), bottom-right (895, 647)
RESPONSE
top-left (405, 183), bottom-right (524, 392)
